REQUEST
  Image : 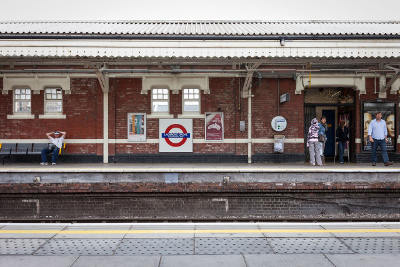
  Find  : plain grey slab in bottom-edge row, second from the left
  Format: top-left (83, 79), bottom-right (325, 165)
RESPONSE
top-left (71, 256), bottom-right (160, 267)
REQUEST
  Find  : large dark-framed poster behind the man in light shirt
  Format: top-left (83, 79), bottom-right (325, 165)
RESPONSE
top-left (362, 102), bottom-right (396, 151)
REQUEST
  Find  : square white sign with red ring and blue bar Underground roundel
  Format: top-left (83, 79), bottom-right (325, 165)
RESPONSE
top-left (159, 119), bottom-right (193, 152)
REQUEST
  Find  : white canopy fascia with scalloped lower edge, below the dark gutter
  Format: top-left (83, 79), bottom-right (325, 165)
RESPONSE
top-left (0, 40), bottom-right (400, 58)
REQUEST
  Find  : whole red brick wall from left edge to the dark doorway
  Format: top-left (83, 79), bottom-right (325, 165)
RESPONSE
top-left (0, 77), bottom-right (304, 155)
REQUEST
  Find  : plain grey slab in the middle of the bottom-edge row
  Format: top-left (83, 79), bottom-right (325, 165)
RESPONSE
top-left (160, 255), bottom-right (246, 267)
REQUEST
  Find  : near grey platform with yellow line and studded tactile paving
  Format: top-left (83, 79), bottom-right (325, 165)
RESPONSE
top-left (0, 222), bottom-right (400, 267)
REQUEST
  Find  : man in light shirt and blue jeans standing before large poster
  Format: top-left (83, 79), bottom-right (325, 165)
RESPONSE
top-left (368, 112), bottom-right (393, 166)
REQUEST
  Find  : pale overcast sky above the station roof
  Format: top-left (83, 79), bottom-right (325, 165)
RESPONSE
top-left (0, 0), bottom-right (400, 21)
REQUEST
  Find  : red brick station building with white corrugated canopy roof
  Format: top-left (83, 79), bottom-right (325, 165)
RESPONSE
top-left (0, 21), bottom-right (400, 163)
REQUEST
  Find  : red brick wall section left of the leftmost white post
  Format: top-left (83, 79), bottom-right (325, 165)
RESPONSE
top-left (0, 79), bottom-right (103, 154)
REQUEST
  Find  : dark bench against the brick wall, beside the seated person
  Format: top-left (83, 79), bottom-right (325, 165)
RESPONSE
top-left (0, 143), bottom-right (66, 165)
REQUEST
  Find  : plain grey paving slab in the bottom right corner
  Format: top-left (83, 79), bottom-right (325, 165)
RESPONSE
top-left (326, 254), bottom-right (400, 267)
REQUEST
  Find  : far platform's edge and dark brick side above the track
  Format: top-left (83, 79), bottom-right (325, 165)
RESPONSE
top-left (0, 163), bottom-right (400, 222)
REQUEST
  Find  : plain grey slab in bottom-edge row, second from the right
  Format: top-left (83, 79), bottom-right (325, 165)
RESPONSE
top-left (244, 254), bottom-right (334, 267)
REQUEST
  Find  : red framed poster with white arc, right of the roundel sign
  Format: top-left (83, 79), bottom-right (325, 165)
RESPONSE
top-left (205, 112), bottom-right (224, 141)
